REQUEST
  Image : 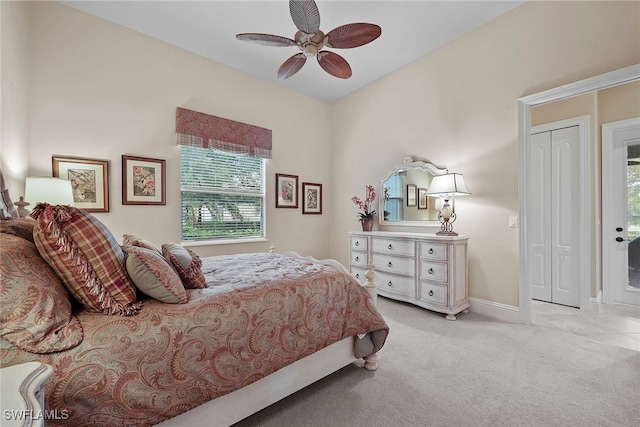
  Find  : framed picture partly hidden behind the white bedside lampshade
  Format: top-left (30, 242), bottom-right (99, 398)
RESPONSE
top-left (52, 156), bottom-right (109, 212)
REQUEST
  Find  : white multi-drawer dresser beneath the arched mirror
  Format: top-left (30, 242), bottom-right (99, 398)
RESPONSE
top-left (349, 231), bottom-right (469, 320)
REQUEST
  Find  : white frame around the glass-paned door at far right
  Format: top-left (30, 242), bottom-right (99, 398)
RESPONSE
top-left (602, 117), bottom-right (640, 304)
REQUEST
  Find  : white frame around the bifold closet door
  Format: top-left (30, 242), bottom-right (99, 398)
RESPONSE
top-left (525, 116), bottom-right (592, 308)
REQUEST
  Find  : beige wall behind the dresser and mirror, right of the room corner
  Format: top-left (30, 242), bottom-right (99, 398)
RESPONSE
top-left (332, 2), bottom-right (640, 306)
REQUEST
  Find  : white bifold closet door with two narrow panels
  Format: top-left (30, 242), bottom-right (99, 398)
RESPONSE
top-left (529, 126), bottom-right (587, 307)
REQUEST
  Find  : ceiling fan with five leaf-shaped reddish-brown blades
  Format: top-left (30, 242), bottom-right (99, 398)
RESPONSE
top-left (236, 0), bottom-right (382, 79)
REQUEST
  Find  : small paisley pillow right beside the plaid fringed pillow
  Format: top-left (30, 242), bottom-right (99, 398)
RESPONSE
top-left (122, 246), bottom-right (187, 304)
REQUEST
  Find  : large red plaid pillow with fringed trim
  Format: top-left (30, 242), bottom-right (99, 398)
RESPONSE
top-left (31, 203), bottom-right (142, 316)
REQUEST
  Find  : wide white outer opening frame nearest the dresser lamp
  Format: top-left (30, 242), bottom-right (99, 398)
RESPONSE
top-left (518, 64), bottom-right (640, 324)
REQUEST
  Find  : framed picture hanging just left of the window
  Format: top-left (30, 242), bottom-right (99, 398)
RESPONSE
top-left (122, 155), bottom-right (167, 205)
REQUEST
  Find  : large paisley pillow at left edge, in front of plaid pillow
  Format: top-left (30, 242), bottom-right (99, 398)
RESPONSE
top-left (0, 233), bottom-right (84, 353)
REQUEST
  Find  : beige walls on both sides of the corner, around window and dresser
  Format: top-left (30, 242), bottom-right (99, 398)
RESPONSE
top-left (2, 2), bottom-right (640, 306)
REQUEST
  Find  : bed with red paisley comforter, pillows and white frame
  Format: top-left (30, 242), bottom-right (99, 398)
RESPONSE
top-left (0, 170), bottom-right (388, 426)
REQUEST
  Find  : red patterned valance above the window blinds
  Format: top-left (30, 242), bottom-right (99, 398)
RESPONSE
top-left (176, 107), bottom-right (271, 159)
